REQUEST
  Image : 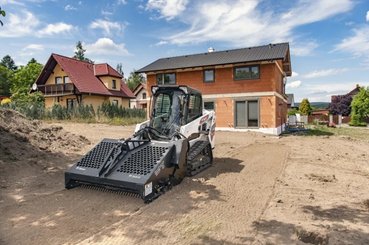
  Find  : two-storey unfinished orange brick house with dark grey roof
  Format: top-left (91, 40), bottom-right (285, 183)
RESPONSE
top-left (137, 43), bottom-right (292, 135)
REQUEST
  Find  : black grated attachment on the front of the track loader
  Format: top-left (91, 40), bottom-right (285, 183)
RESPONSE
top-left (65, 139), bottom-right (188, 202)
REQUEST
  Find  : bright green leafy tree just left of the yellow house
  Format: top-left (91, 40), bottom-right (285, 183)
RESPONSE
top-left (10, 59), bottom-right (43, 96)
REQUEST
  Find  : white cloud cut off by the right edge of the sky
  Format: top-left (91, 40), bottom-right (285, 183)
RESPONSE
top-left (335, 26), bottom-right (369, 59)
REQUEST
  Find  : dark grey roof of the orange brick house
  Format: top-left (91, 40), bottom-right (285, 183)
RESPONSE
top-left (136, 43), bottom-right (289, 73)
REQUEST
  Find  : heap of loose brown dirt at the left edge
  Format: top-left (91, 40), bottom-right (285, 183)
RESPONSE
top-left (0, 109), bottom-right (90, 160)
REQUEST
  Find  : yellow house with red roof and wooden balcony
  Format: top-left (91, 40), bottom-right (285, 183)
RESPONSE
top-left (36, 54), bottom-right (134, 110)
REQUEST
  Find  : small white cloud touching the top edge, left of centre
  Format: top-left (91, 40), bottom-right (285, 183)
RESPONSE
top-left (146, 0), bottom-right (188, 20)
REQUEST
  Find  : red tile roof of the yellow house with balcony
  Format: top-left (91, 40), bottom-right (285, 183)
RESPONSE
top-left (36, 54), bottom-right (135, 98)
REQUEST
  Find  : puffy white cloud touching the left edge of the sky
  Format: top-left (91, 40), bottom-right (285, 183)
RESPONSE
top-left (0, 10), bottom-right (40, 37)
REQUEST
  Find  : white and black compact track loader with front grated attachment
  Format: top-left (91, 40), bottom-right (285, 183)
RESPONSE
top-left (65, 86), bottom-right (215, 202)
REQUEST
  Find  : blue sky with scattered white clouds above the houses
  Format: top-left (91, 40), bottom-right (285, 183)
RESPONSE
top-left (0, 0), bottom-right (369, 101)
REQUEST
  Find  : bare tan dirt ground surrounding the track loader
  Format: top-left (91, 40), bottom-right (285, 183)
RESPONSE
top-left (0, 110), bottom-right (369, 244)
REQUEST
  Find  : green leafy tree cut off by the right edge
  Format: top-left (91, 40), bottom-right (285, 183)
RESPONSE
top-left (350, 87), bottom-right (369, 126)
